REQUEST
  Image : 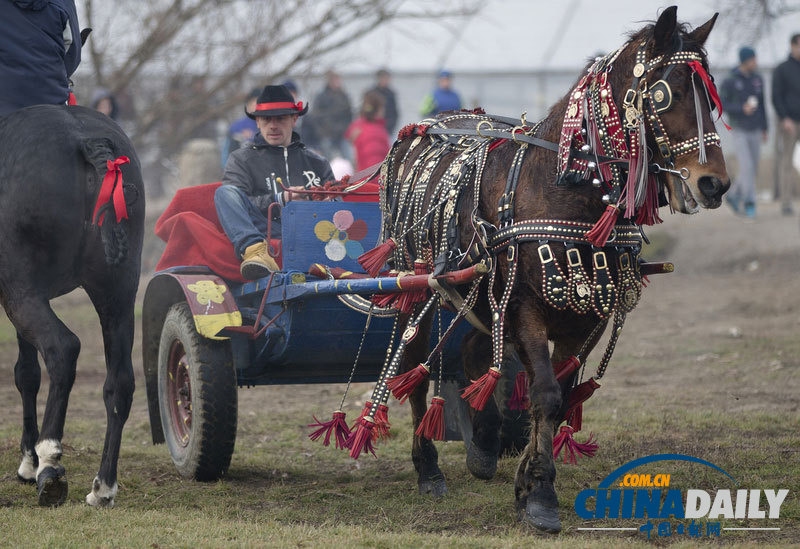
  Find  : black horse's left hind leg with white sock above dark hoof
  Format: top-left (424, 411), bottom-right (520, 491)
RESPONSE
top-left (5, 291), bottom-right (81, 506)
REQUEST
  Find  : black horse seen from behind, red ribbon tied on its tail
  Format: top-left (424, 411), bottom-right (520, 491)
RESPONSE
top-left (0, 105), bottom-right (145, 507)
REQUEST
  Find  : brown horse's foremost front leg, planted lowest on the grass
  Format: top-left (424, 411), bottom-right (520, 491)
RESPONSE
top-left (514, 318), bottom-right (561, 532)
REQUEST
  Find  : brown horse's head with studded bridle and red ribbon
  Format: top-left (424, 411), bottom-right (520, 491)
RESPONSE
top-left (615, 6), bottom-right (730, 214)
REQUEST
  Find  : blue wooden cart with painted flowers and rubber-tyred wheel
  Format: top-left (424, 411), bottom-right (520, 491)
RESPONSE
top-left (142, 202), bottom-right (506, 480)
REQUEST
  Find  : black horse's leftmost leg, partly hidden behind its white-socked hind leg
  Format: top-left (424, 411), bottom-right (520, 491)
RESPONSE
top-left (14, 333), bottom-right (42, 484)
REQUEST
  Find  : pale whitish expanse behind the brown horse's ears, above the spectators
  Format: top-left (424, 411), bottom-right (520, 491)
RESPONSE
top-left (338, 0), bottom-right (800, 72)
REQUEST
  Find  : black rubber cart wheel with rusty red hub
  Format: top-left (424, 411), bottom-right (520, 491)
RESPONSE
top-left (158, 302), bottom-right (237, 480)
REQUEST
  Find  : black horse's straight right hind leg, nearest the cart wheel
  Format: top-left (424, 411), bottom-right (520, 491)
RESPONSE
top-left (86, 288), bottom-right (135, 507)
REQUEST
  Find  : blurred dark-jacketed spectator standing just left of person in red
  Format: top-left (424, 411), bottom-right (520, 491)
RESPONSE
top-left (311, 71), bottom-right (353, 159)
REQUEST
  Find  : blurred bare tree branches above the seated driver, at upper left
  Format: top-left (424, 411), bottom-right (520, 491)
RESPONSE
top-left (82, 0), bottom-right (480, 163)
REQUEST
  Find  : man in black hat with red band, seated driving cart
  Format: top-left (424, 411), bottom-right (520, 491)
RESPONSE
top-left (214, 86), bottom-right (334, 280)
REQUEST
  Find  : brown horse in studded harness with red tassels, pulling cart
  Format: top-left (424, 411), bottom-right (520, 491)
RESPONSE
top-left (356, 6), bottom-right (730, 532)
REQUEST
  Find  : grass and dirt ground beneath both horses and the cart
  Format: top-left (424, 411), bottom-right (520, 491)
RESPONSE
top-left (0, 204), bottom-right (800, 548)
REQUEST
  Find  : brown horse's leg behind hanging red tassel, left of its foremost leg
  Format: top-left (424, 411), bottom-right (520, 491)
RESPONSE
top-left (461, 330), bottom-right (503, 480)
